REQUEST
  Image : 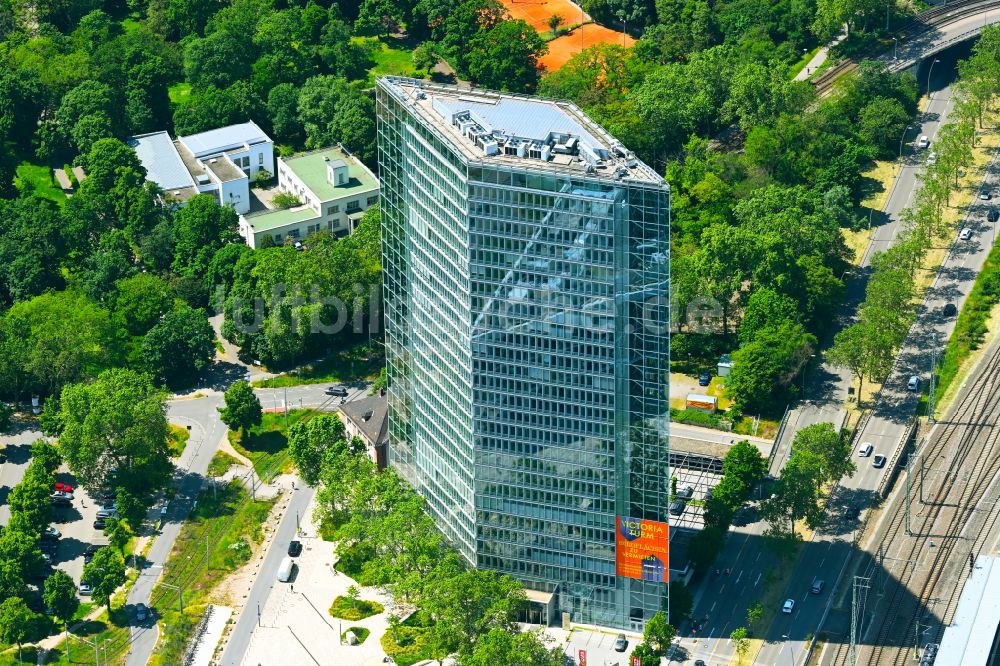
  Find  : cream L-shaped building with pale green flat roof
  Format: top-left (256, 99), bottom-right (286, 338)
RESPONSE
top-left (240, 146), bottom-right (379, 248)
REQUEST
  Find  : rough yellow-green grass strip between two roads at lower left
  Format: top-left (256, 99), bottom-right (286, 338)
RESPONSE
top-left (149, 481), bottom-right (274, 666)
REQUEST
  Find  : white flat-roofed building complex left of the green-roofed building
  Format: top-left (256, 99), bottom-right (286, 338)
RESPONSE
top-left (128, 121), bottom-right (274, 214)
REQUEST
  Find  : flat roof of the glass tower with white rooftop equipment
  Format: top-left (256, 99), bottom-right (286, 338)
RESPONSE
top-left (380, 77), bottom-right (663, 185)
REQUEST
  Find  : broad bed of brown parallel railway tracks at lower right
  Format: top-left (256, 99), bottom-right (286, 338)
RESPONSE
top-left (834, 344), bottom-right (1000, 665)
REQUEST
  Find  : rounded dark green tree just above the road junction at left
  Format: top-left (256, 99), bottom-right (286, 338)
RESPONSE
top-left (142, 303), bottom-right (215, 388)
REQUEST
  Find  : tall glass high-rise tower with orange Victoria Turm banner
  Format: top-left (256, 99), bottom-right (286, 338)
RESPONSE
top-left (377, 78), bottom-right (670, 628)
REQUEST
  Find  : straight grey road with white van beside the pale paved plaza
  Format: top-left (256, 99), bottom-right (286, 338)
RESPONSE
top-left (220, 484), bottom-right (315, 666)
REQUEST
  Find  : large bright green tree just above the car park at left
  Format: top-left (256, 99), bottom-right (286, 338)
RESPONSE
top-left (59, 369), bottom-right (171, 494)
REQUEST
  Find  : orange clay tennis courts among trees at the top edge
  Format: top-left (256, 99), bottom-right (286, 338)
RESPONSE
top-left (501, 0), bottom-right (635, 72)
